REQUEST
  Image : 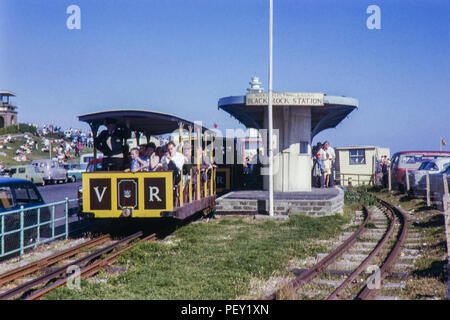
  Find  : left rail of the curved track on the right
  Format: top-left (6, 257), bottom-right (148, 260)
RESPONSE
top-left (265, 206), bottom-right (371, 300)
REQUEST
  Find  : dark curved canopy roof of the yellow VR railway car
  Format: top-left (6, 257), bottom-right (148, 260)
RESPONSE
top-left (78, 109), bottom-right (208, 135)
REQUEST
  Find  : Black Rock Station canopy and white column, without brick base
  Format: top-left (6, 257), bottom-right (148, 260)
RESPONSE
top-left (218, 77), bottom-right (358, 192)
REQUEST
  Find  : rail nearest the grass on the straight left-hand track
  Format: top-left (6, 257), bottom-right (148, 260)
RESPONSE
top-left (24, 233), bottom-right (156, 300)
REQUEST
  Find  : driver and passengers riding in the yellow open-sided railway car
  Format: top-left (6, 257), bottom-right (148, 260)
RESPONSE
top-left (95, 119), bottom-right (213, 183)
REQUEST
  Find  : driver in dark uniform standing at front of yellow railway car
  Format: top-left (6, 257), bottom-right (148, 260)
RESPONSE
top-left (94, 119), bottom-right (131, 171)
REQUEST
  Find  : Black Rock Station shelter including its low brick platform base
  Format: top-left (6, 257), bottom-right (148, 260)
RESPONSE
top-left (216, 76), bottom-right (358, 216)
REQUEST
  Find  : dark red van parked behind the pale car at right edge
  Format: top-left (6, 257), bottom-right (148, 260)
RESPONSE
top-left (391, 151), bottom-right (450, 192)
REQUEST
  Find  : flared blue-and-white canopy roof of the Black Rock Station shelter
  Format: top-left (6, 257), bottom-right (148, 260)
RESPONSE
top-left (218, 95), bottom-right (358, 138)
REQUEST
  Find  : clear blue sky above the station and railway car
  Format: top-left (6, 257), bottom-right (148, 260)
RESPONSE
top-left (0, 0), bottom-right (450, 153)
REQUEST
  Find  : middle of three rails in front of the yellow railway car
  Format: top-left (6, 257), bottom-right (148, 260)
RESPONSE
top-left (0, 231), bottom-right (143, 300)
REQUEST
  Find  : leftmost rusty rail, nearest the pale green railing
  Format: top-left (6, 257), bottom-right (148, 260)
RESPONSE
top-left (0, 235), bottom-right (110, 286)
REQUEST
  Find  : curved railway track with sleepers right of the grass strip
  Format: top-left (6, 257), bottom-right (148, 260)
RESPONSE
top-left (266, 200), bottom-right (408, 300)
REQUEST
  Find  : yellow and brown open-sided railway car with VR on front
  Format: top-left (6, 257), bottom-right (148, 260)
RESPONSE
top-left (78, 110), bottom-right (216, 219)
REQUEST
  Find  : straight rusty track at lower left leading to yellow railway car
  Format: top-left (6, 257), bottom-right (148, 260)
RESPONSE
top-left (0, 231), bottom-right (156, 300)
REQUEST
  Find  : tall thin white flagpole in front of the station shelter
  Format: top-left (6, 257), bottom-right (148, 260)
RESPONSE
top-left (268, 0), bottom-right (274, 216)
